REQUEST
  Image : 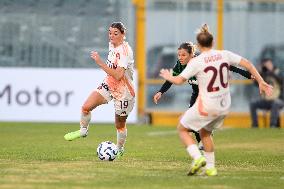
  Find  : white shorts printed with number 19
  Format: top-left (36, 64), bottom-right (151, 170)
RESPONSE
top-left (95, 82), bottom-right (135, 116)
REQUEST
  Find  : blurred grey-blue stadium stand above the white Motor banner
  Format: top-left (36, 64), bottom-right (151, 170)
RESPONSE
top-left (0, 0), bottom-right (124, 67)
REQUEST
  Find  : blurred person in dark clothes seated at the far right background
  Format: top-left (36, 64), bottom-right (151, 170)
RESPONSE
top-left (250, 59), bottom-right (284, 128)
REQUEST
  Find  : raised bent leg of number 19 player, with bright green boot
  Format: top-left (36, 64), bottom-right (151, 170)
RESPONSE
top-left (64, 91), bottom-right (107, 141)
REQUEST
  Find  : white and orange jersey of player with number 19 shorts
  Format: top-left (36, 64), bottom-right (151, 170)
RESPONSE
top-left (104, 42), bottom-right (135, 100)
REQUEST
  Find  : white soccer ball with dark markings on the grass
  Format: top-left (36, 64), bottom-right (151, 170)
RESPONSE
top-left (97, 141), bottom-right (118, 161)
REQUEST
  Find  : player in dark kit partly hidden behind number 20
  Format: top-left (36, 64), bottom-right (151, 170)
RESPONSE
top-left (153, 42), bottom-right (251, 150)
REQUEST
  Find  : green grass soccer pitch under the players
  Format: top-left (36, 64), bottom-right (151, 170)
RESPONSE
top-left (0, 123), bottom-right (284, 189)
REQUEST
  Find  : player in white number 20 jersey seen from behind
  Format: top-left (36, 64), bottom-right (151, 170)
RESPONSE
top-left (160, 24), bottom-right (273, 176)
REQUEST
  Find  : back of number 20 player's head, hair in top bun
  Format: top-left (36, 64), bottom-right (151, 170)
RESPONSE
top-left (196, 24), bottom-right (213, 47)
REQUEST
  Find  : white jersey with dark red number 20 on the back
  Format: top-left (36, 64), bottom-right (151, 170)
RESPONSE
top-left (180, 49), bottom-right (242, 116)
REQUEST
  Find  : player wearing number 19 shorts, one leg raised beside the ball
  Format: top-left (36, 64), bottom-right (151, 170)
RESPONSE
top-left (64, 22), bottom-right (135, 157)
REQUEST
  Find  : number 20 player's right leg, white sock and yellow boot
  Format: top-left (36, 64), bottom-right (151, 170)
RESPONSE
top-left (200, 129), bottom-right (217, 176)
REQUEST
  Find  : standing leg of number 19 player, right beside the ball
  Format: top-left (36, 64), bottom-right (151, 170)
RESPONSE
top-left (115, 114), bottom-right (127, 158)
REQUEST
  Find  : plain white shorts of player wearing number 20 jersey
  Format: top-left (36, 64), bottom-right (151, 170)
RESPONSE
top-left (180, 102), bottom-right (226, 131)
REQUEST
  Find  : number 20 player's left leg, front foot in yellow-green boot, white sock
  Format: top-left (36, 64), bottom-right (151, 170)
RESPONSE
top-left (177, 124), bottom-right (206, 175)
